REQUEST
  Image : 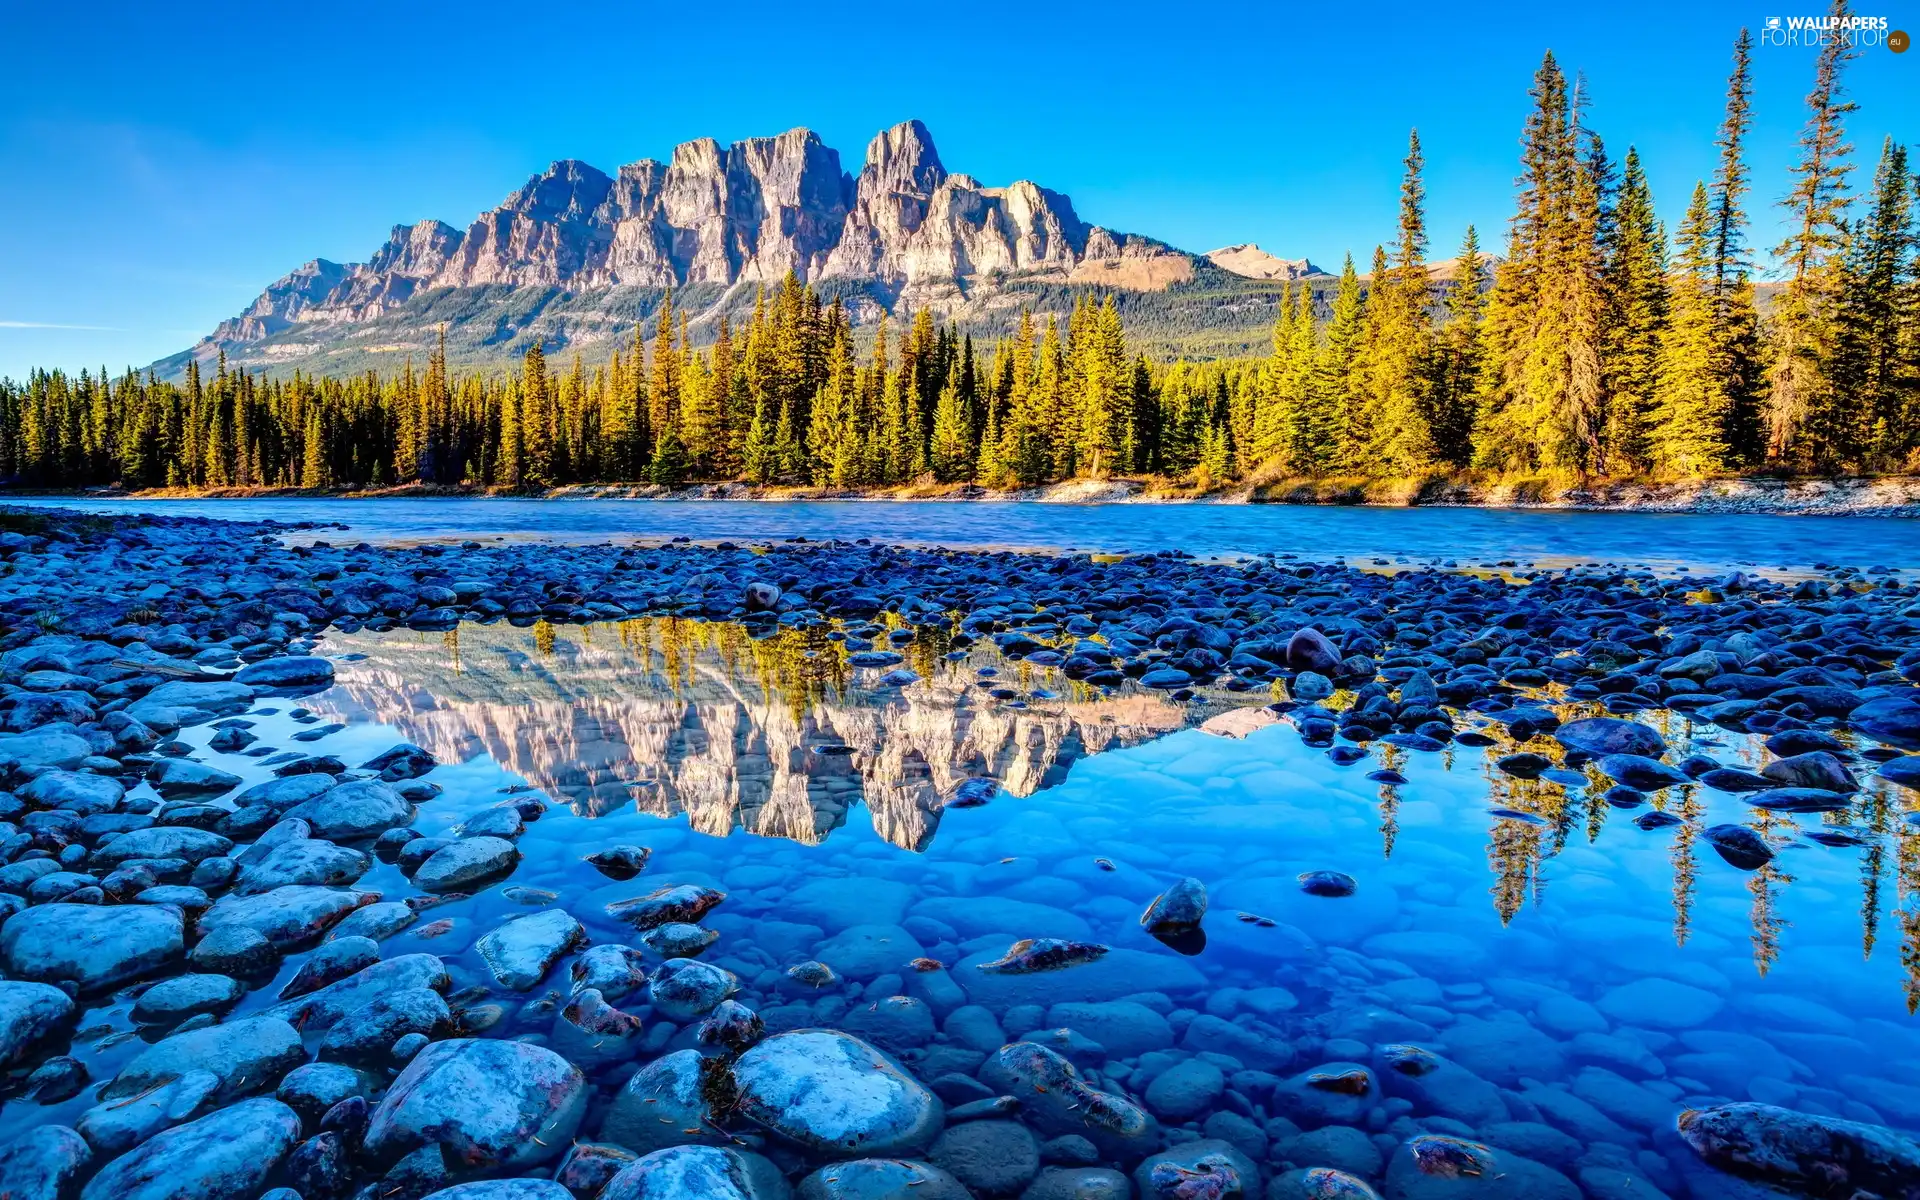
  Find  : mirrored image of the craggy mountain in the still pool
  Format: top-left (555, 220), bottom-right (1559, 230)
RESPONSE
top-left (313, 616), bottom-right (1213, 849)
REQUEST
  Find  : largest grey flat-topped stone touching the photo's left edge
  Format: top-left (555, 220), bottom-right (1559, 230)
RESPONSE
top-left (0, 904), bottom-right (186, 993)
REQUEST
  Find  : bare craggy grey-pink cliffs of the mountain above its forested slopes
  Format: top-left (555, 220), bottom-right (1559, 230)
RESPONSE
top-left (194, 121), bottom-right (1194, 357)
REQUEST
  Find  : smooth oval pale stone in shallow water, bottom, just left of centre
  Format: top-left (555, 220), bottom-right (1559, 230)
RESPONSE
top-left (733, 1029), bottom-right (945, 1158)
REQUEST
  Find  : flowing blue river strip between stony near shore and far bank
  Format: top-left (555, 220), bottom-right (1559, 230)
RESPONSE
top-left (6, 497), bottom-right (1920, 570)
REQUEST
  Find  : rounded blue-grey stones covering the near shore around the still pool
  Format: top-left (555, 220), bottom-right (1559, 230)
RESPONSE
top-left (0, 513), bottom-right (1920, 1200)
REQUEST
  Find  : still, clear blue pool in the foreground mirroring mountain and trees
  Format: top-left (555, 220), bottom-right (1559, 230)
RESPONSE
top-left (22, 618), bottom-right (1920, 1200)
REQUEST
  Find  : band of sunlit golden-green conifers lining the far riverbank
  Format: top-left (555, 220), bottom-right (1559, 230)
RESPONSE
top-left (0, 29), bottom-right (1920, 490)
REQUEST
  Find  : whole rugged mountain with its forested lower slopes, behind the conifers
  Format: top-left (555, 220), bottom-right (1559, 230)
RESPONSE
top-left (156, 121), bottom-right (1313, 374)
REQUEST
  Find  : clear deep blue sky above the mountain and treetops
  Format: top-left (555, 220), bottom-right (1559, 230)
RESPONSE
top-left (0, 0), bottom-right (1920, 378)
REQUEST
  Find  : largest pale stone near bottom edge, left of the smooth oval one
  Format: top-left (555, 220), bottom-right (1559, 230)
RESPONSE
top-left (367, 1039), bottom-right (588, 1171)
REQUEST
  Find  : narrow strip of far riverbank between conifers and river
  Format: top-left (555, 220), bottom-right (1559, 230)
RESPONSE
top-left (0, 474), bottom-right (1920, 516)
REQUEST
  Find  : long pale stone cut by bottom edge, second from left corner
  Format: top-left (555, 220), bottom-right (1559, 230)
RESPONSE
top-left (81, 1098), bottom-right (300, 1200)
